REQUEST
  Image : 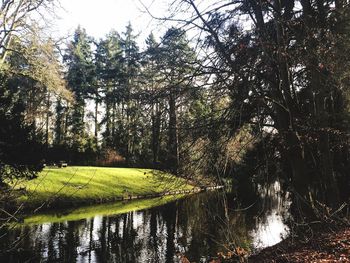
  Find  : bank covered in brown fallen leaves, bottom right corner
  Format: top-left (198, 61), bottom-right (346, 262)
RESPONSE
top-left (249, 226), bottom-right (350, 263)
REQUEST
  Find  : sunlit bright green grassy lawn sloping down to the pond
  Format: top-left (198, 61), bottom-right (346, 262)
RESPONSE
top-left (15, 166), bottom-right (192, 210)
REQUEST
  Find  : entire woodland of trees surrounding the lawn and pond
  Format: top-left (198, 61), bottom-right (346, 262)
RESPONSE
top-left (0, 0), bottom-right (350, 262)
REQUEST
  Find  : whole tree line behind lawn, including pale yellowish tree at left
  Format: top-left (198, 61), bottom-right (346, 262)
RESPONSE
top-left (0, 3), bottom-right (216, 182)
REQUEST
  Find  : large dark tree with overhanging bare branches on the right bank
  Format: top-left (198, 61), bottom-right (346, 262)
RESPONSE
top-left (166, 0), bottom-right (350, 210)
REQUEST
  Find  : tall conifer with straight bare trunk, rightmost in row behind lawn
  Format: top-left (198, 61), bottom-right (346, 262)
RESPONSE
top-left (160, 27), bottom-right (195, 173)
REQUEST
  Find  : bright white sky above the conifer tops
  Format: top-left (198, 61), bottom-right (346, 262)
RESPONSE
top-left (50, 0), bottom-right (226, 47)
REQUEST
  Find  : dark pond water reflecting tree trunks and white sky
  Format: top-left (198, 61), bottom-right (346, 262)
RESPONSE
top-left (0, 183), bottom-right (288, 262)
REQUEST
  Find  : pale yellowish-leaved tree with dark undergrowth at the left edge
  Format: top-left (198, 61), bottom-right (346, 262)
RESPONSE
top-left (0, 25), bottom-right (71, 181)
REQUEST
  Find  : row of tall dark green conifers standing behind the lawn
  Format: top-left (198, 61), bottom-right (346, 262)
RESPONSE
top-left (54, 24), bottom-right (205, 175)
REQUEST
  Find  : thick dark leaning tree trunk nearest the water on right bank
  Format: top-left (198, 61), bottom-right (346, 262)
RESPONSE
top-left (274, 1), bottom-right (311, 215)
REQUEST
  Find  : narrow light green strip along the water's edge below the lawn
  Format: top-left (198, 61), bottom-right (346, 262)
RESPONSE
top-left (19, 195), bottom-right (183, 226)
